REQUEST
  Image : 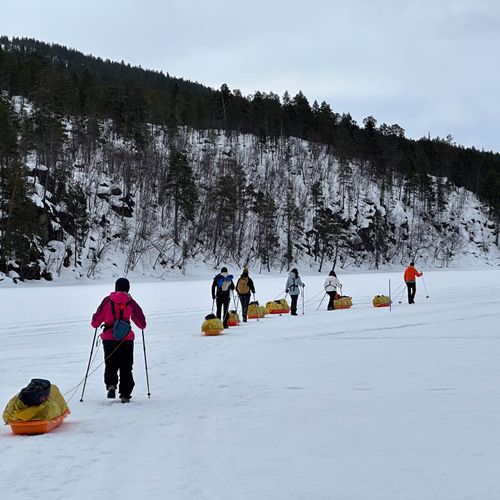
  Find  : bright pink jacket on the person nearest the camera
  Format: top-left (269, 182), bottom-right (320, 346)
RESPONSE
top-left (90, 292), bottom-right (146, 340)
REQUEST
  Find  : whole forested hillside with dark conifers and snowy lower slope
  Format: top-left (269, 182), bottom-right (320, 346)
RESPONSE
top-left (0, 37), bottom-right (500, 279)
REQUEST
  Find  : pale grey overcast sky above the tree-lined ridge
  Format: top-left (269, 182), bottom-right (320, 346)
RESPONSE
top-left (0, 0), bottom-right (500, 151)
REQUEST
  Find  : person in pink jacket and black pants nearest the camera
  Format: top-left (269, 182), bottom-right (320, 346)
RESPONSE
top-left (91, 278), bottom-right (146, 403)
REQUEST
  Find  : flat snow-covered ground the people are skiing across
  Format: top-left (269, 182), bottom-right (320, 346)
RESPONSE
top-left (0, 270), bottom-right (500, 500)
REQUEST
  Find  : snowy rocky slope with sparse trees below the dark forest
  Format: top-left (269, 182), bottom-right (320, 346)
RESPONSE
top-left (4, 97), bottom-right (500, 282)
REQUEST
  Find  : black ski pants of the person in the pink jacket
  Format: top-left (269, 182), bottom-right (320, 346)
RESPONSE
top-left (102, 340), bottom-right (135, 397)
